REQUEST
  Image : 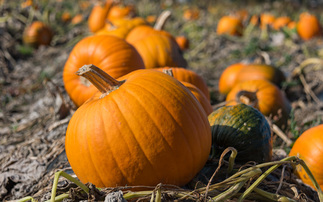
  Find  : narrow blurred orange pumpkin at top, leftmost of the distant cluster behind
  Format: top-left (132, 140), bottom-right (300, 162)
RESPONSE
top-left (88, 0), bottom-right (113, 32)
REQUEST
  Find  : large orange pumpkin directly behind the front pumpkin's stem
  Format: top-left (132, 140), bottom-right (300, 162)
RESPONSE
top-left (63, 35), bottom-right (145, 106)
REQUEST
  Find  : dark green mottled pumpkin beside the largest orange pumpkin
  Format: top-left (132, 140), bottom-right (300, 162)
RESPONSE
top-left (208, 104), bottom-right (272, 163)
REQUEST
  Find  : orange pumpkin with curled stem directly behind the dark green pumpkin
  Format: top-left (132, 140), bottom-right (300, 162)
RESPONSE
top-left (226, 80), bottom-right (291, 127)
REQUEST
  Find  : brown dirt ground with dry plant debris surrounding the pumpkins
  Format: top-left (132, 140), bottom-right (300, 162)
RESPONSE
top-left (0, 0), bottom-right (323, 201)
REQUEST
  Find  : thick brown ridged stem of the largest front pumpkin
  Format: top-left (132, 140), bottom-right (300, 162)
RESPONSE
top-left (76, 64), bottom-right (124, 97)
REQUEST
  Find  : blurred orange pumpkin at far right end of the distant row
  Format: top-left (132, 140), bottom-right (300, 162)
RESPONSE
top-left (296, 12), bottom-right (321, 40)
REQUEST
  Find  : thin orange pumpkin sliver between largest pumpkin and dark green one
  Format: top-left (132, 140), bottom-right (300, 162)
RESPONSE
top-left (181, 81), bottom-right (213, 115)
